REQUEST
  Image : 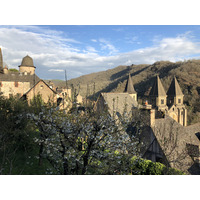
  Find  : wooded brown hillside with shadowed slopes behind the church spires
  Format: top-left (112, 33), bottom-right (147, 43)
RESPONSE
top-left (49, 60), bottom-right (200, 124)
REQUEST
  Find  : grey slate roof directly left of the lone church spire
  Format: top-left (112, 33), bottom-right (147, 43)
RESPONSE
top-left (101, 93), bottom-right (138, 115)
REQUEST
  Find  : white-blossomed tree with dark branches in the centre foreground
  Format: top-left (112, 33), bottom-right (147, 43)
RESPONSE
top-left (30, 105), bottom-right (144, 174)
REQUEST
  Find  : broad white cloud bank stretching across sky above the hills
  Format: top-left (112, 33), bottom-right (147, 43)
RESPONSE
top-left (0, 26), bottom-right (200, 79)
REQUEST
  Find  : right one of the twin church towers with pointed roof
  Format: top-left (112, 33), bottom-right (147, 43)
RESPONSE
top-left (167, 76), bottom-right (187, 126)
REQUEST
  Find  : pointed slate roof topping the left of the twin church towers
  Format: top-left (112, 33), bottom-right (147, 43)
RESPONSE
top-left (149, 76), bottom-right (166, 96)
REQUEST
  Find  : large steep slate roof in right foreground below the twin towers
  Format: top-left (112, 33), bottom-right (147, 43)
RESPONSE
top-left (153, 116), bottom-right (200, 174)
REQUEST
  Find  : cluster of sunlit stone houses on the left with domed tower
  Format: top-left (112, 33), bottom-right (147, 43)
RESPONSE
top-left (0, 48), bottom-right (82, 109)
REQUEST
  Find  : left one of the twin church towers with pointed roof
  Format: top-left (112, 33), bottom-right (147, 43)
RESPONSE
top-left (149, 75), bottom-right (168, 112)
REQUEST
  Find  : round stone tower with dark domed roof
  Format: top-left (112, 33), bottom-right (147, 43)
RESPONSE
top-left (19, 55), bottom-right (36, 75)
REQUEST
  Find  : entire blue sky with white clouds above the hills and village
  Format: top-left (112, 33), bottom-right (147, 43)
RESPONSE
top-left (0, 25), bottom-right (200, 80)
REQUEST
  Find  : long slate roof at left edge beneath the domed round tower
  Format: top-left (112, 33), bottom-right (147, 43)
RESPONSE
top-left (0, 72), bottom-right (40, 87)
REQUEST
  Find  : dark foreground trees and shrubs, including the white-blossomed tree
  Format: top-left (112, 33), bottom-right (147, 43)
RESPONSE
top-left (0, 98), bottom-right (185, 174)
